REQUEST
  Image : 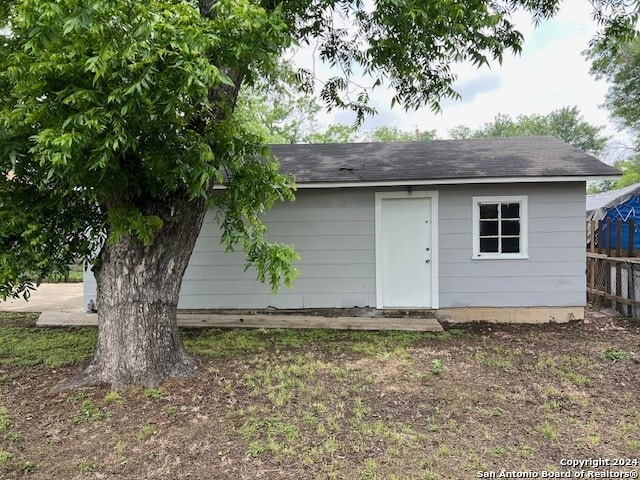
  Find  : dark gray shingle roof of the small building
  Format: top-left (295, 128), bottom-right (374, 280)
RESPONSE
top-left (271, 137), bottom-right (620, 184)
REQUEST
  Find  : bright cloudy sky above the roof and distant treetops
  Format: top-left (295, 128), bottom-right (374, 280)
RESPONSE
top-left (294, 0), bottom-right (628, 159)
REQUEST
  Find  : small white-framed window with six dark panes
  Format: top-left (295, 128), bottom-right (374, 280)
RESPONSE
top-left (472, 196), bottom-right (529, 259)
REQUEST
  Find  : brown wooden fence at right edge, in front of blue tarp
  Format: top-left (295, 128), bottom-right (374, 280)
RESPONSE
top-left (587, 219), bottom-right (640, 319)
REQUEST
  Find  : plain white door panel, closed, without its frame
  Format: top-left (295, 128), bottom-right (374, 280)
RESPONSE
top-left (376, 192), bottom-right (434, 308)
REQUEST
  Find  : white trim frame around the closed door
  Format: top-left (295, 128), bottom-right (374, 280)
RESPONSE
top-left (375, 189), bottom-right (440, 309)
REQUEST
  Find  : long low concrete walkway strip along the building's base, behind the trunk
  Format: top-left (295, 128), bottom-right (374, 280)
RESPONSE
top-left (37, 312), bottom-right (443, 332)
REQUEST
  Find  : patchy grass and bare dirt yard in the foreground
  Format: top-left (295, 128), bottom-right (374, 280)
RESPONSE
top-left (0, 312), bottom-right (640, 480)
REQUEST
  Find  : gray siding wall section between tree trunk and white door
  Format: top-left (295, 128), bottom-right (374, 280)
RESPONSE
top-left (178, 188), bottom-right (375, 309)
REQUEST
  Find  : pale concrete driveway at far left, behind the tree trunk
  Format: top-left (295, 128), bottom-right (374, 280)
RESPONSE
top-left (0, 283), bottom-right (84, 313)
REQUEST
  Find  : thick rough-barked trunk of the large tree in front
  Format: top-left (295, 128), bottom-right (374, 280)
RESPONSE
top-left (59, 194), bottom-right (205, 390)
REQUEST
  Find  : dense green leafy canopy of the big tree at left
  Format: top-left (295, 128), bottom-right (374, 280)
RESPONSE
top-left (0, 0), bottom-right (293, 295)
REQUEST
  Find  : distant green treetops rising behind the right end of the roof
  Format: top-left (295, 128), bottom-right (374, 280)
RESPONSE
top-left (449, 107), bottom-right (608, 155)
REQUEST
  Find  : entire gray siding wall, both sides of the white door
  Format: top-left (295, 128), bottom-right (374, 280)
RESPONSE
top-left (85, 182), bottom-right (586, 309)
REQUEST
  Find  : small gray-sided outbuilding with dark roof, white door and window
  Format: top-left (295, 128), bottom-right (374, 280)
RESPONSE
top-left (85, 137), bottom-right (619, 322)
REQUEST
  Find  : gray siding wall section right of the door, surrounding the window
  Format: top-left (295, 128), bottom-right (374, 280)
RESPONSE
top-left (439, 182), bottom-right (586, 307)
